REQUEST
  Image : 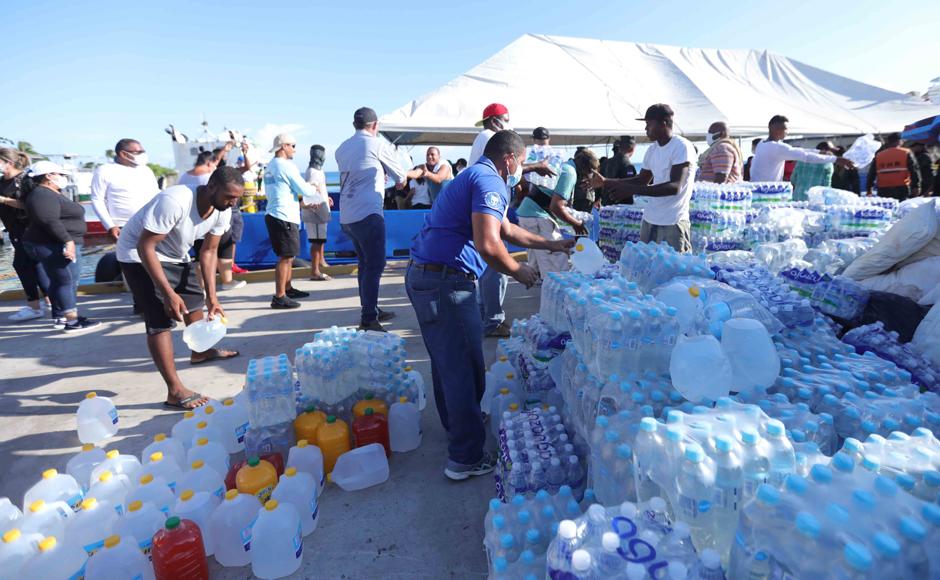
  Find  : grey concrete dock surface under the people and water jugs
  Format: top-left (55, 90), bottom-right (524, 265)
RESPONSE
top-left (0, 262), bottom-right (539, 579)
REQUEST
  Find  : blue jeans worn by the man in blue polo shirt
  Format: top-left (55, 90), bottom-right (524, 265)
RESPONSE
top-left (405, 266), bottom-right (486, 465)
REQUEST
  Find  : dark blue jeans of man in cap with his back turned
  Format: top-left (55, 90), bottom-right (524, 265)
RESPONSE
top-left (342, 214), bottom-right (385, 324)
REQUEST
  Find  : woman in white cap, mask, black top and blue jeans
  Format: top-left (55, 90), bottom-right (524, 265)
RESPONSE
top-left (23, 161), bottom-right (101, 334)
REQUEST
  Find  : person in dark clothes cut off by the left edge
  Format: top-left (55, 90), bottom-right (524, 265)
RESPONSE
top-left (0, 147), bottom-right (49, 322)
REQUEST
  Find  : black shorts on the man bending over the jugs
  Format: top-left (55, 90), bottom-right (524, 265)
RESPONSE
top-left (121, 262), bottom-right (206, 334)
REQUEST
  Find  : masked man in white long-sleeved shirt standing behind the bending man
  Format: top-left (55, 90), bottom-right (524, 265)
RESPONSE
top-left (91, 139), bottom-right (160, 240)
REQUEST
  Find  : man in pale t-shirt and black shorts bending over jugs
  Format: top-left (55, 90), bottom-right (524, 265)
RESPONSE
top-left (117, 167), bottom-right (245, 410)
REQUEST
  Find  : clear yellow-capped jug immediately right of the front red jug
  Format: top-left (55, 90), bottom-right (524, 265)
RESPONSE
top-left (209, 489), bottom-right (262, 567)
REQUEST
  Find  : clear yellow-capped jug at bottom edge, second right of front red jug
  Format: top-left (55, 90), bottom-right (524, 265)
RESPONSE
top-left (250, 498), bottom-right (302, 579)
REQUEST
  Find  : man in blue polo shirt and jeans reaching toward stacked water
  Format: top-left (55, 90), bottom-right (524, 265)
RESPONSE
top-left (405, 131), bottom-right (574, 480)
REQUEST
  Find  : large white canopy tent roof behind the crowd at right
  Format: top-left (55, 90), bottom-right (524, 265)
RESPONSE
top-left (380, 34), bottom-right (940, 145)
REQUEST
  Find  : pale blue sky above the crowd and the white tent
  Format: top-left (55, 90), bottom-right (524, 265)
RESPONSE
top-left (0, 0), bottom-right (940, 169)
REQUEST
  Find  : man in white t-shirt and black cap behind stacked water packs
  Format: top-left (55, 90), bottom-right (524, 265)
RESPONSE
top-left (592, 103), bottom-right (698, 252)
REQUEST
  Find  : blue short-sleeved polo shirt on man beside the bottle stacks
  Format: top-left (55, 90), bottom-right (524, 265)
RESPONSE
top-left (411, 157), bottom-right (509, 277)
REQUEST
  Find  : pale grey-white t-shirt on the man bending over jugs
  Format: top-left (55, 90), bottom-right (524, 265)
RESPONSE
top-left (117, 185), bottom-right (232, 263)
